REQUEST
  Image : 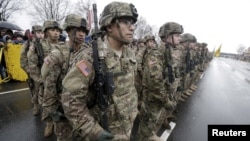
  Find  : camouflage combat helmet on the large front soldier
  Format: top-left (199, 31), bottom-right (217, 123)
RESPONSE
top-left (99, 2), bottom-right (138, 30)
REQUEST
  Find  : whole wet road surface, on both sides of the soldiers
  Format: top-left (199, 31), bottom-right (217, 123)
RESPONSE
top-left (0, 58), bottom-right (250, 141)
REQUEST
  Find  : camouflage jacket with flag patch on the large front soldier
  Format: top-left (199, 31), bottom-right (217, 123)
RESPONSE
top-left (62, 38), bottom-right (138, 140)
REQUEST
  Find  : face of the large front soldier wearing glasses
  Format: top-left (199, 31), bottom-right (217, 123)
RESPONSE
top-left (108, 18), bottom-right (135, 43)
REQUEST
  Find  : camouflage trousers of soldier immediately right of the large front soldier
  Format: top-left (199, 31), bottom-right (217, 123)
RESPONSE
top-left (138, 102), bottom-right (166, 141)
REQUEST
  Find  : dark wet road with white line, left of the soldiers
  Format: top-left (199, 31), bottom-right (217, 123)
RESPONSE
top-left (0, 82), bottom-right (56, 141)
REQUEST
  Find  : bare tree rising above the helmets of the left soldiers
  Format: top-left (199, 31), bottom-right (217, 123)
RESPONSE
top-left (28, 0), bottom-right (70, 23)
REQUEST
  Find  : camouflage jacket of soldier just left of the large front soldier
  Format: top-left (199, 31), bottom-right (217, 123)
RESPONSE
top-left (41, 42), bottom-right (90, 106)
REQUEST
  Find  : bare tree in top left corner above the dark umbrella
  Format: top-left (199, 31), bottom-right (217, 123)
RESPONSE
top-left (0, 0), bottom-right (25, 21)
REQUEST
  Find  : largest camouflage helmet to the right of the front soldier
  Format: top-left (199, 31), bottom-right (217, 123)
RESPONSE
top-left (159, 22), bottom-right (183, 37)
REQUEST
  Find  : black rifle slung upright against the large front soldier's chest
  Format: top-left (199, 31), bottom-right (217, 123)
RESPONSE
top-left (92, 4), bottom-right (114, 131)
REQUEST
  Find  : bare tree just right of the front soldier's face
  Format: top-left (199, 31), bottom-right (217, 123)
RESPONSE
top-left (135, 16), bottom-right (154, 39)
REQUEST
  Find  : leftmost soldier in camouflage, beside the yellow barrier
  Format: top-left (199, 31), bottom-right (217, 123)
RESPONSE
top-left (20, 25), bottom-right (44, 116)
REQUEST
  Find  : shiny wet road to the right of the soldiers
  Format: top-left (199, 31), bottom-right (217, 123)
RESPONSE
top-left (168, 58), bottom-right (250, 141)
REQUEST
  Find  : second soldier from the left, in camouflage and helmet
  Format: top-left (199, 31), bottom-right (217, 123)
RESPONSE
top-left (28, 20), bottom-right (62, 137)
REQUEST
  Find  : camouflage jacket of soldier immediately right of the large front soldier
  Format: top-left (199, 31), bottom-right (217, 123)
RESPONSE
top-left (142, 45), bottom-right (168, 106)
